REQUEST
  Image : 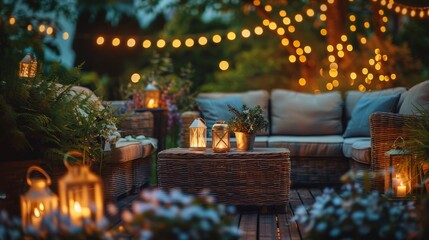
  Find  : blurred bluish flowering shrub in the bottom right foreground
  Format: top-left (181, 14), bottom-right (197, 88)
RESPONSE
top-left (293, 172), bottom-right (418, 239)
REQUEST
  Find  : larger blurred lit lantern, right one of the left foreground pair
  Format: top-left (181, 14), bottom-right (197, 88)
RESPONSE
top-left (58, 151), bottom-right (103, 225)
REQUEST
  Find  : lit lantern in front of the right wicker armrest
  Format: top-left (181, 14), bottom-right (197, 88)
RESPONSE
top-left (384, 137), bottom-right (416, 197)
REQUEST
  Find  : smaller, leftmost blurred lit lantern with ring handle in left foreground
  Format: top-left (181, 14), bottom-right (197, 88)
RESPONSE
top-left (21, 166), bottom-right (58, 229)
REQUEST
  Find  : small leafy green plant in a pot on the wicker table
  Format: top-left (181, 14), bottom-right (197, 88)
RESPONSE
top-left (228, 104), bottom-right (268, 151)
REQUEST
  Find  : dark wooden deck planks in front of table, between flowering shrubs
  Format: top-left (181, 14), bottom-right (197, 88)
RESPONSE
top-left (112, 188), bottom-right (322, 240)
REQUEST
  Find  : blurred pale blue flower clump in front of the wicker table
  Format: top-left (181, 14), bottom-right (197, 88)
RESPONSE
top-left (115, 190), bottom-right (239, 240)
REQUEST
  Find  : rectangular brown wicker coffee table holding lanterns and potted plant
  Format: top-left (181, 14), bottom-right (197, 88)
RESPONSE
top-left (158, 148), bottom-right (290, 206)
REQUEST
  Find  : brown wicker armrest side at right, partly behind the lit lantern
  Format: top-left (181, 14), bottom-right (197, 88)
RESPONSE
top-left (370, 112), bottom-right (418, 192)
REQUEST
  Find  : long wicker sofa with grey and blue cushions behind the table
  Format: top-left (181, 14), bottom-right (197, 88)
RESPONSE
top-left (181, 81), bottom-right (429, 186)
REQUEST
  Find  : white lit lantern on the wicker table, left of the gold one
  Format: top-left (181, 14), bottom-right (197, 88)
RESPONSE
top-left (189, 118), bottom-right (207, 151)
